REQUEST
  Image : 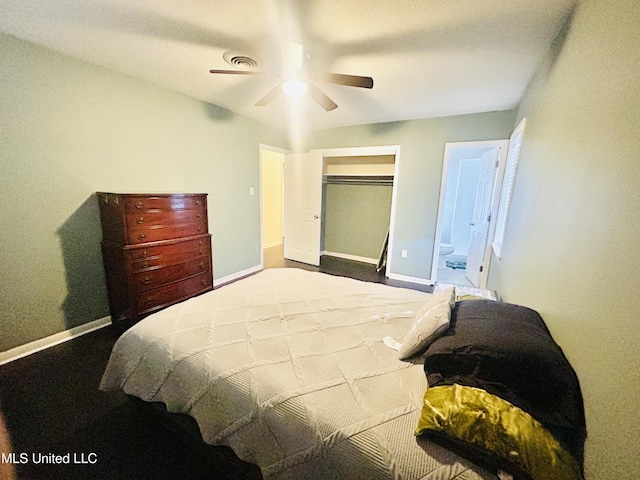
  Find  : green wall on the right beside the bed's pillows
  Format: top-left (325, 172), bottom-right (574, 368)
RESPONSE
top-left (489, 0), bottom-right (640, 480)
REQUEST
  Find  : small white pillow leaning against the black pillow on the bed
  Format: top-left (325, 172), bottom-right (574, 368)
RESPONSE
top-left (399, 287), bottom-right (455, 360)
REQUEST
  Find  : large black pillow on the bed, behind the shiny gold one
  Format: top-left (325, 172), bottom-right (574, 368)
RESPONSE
top-left (424, 300), bottom-right (586, 464)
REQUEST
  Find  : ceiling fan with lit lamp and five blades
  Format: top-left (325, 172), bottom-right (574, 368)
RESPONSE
top-left (209, 42), bottom-right (373, 111)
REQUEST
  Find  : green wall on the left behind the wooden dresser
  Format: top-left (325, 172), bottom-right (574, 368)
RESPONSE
top-left (0, 35), bottom-right (282, 351)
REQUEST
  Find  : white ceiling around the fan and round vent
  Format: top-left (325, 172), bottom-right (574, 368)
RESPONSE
top-left (0, 0), bottom-right (575, 129)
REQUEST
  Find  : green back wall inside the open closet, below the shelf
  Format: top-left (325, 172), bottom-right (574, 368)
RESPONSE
top-left (322, 184), bottom-right (393, 259)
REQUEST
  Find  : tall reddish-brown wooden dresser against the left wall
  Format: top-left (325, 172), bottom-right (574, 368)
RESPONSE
top-left (97, 192), bottom-right (213, 323)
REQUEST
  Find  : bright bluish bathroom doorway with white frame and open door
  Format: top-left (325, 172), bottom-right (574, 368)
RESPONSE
top-left (431, 140), bottom-right (509, 288)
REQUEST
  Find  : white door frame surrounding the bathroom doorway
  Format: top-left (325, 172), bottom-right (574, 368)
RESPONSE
top-left (430, 139), bottom-right (509, 288)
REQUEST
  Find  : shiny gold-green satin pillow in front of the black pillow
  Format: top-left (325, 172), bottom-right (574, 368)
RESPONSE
top-left (415, 384), bottom-right (583, 480)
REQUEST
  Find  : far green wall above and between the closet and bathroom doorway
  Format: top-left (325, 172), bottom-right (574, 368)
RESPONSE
top-left (309, 111), bottom-right (514, 280)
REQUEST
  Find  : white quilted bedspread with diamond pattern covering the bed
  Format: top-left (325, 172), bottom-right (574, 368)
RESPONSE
top-left (100, 269), bottom-right (497, 480)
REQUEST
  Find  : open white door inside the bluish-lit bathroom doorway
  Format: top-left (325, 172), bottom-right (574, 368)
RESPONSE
top-left (465, 148), bottom-right (500, 287)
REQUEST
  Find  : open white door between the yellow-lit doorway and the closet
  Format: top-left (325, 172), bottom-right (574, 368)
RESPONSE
top-left (283, 152), bottom-right (323, 265)
